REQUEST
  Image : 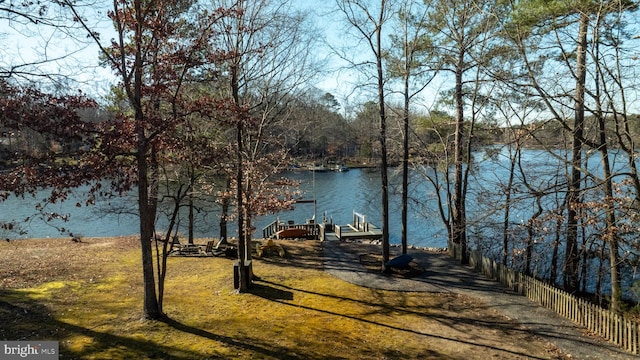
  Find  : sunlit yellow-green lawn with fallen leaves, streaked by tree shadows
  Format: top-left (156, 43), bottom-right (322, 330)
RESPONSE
top-left (0, 238), bottom-right (557, 359)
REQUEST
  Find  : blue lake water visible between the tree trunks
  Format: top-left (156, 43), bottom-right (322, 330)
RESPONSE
top-left (0, 149), bottom-right (640, 296)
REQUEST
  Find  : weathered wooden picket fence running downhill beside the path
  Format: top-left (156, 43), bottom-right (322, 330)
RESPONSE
top-left (449, 243), bottom-right (640, 355)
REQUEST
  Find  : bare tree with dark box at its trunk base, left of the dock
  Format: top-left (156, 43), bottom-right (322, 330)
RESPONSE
top-left (212, 0), bottom-right (317, 292)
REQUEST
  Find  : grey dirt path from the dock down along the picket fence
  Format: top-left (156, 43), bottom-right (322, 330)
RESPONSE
top-left (322, 241), bottom-right (638, 360)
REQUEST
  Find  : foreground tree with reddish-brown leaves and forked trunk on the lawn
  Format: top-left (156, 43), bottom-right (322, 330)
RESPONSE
top-left (64, 0), bottom-right (235, 319)
